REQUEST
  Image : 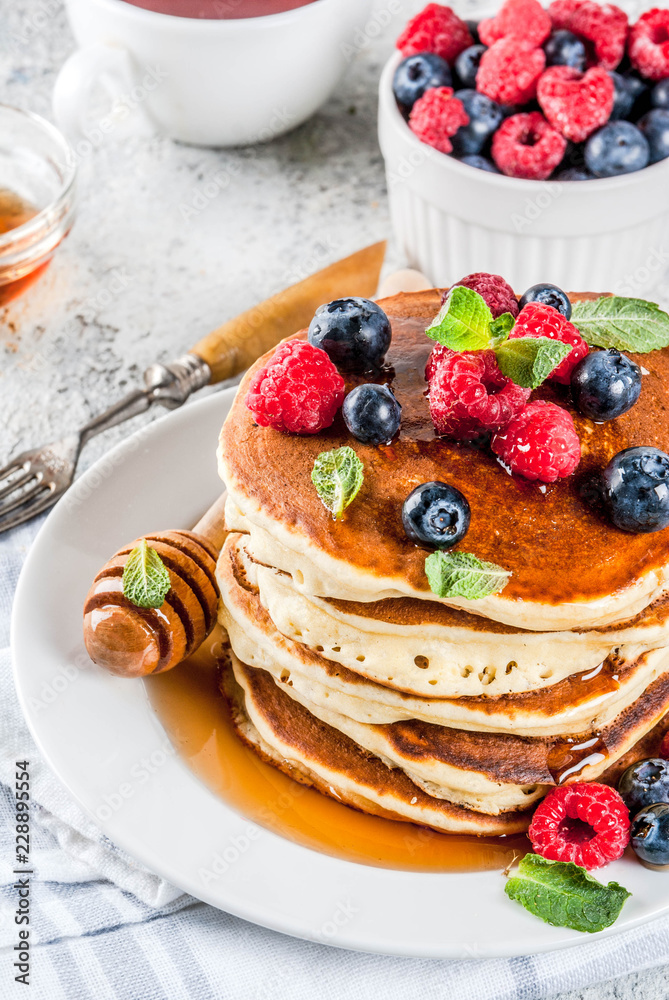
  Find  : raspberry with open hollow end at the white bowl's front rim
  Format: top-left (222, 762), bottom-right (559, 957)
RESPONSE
top-left (492, 111), bottom-right (567, 181)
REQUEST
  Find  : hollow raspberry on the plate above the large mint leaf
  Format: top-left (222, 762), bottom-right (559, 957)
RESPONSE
top-left (529, 781), bottom-right (630, 869)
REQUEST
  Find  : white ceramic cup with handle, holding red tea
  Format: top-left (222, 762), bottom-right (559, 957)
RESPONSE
top-left (53, 0), bottom-right (371, 146)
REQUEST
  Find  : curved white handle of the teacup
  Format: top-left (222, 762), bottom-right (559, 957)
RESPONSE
top-left (52, 45), bottom-right (148, 141)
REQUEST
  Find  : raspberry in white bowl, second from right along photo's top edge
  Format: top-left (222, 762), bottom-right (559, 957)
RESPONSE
top-left (548, 0), bottom-right (627, 69)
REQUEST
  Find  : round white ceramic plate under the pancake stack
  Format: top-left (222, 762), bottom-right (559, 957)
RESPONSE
top-left (12, 389), bottom-right (669, 958)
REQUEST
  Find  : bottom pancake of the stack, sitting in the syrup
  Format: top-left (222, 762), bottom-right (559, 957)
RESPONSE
top-left (222, 652), bottom-right (531, 837)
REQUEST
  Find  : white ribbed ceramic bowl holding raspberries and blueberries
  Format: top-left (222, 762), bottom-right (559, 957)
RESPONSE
top-left (379, 52), bottom-right (669, 296)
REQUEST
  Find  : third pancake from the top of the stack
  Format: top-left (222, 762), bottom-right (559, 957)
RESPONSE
top-left (217, 535), bottom-right (669, 736)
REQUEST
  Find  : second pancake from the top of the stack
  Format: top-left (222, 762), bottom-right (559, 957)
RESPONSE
top-left (235, 535), bottom-right (669, 697)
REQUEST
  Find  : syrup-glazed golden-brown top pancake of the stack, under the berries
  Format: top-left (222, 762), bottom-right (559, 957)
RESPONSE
top-left (219, 290), bottom-right (669, 631)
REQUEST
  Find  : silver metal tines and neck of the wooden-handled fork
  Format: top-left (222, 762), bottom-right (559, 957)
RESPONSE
top-left (0, 354), bottom-right (211, 533)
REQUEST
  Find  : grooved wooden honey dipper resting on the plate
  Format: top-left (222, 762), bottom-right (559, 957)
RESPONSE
top-left (84, 493), bottom-right (226, 677)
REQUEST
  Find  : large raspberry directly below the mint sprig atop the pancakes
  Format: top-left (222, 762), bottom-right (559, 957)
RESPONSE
top-left (425, 344), bottom-right (530, 440)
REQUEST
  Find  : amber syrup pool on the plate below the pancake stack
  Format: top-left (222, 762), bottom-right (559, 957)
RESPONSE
top-left (145, 631), bottom-right (529, 872)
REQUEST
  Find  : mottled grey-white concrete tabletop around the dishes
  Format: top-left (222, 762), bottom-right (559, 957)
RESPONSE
top-left (0, 0), bottom-right (669, 1000)
